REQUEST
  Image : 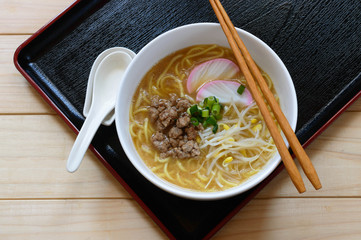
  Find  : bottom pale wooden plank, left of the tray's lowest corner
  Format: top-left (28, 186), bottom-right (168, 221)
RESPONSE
top-left (0, 199), bottom-right (166, 240)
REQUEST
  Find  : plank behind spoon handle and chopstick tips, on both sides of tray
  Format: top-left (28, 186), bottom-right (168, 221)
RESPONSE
top-left (0, 112), bottom-right (361, 198)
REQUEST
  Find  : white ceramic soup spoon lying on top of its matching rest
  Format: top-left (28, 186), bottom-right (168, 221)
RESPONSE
top-left (66, 52), bottom-right (132, 172)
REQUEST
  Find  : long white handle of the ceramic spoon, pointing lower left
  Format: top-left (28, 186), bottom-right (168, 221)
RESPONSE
top-left (66, 109), bottom-right (109, 172)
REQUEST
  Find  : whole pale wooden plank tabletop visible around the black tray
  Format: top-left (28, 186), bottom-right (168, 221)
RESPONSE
top-left (0, 0), bottom-right (361, 239)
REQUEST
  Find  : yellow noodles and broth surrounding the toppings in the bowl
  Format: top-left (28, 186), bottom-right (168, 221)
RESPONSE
top-left (129, 45), bottom-right (275, 192)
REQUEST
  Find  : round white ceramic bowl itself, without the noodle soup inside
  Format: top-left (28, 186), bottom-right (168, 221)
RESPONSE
top-left (115, 23), bottom-right (297, 200)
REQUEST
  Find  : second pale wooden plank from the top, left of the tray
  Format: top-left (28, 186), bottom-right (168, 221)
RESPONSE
top-left (0, 35), bottom-right (54, 114)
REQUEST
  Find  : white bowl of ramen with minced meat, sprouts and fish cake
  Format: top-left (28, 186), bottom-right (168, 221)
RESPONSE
top-left (115, 23), bottom-right (297, 200)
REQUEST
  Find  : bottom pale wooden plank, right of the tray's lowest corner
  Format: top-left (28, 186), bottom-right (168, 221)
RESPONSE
top-left (214, 198), bottom-right (361, 240)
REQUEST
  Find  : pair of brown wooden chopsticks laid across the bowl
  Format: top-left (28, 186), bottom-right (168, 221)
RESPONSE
top-left (209, 0), bottom-right (322, 193)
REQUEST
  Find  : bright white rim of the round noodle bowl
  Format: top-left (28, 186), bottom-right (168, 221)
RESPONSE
top-left (115, 22), bottom-right (298, 200)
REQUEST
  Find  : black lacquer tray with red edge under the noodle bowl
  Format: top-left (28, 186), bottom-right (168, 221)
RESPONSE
top-left (14, 0), bottom-right (361, 239)
